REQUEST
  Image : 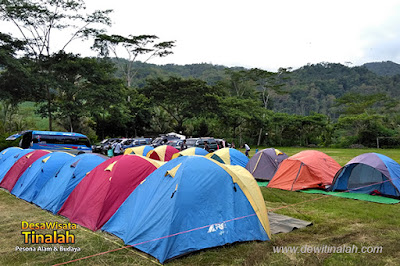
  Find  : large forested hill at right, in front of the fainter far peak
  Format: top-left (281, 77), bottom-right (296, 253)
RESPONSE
top-left (272, 63), bottom-right (400, 118)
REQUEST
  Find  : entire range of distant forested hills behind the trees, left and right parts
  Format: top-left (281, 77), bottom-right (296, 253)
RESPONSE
top-left (115, 61), bottom-right (400, 119)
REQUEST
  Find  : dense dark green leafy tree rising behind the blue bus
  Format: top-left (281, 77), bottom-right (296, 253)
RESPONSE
top-left (42, 52), bottom-right (124, 131)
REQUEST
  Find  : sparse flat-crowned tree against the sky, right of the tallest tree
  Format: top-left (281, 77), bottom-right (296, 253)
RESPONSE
top-left (93, 34), bottom-right (175, 87)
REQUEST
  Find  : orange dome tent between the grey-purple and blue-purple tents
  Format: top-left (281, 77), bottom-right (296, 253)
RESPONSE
top-left (267, 150), bottom-right (340, 190)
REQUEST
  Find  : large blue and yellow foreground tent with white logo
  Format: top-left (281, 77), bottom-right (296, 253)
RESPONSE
top-left (102, 156), bottom-right (270, 263)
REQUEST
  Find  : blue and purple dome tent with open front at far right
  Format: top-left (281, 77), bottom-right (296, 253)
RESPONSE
top-left (331, 153), bottom-right (400, 197)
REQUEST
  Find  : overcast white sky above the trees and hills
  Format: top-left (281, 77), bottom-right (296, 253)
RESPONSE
top-left (7, 0), bottom-right (400, 71)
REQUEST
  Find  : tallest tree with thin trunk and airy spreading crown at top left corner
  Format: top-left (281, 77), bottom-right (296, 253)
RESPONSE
top-left (0, 0), bottom-right (111, 130)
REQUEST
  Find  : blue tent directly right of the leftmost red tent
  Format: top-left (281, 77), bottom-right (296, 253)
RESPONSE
top-left (11, 152), bottom-right (75, 202)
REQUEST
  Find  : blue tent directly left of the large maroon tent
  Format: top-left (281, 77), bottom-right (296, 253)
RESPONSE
top-left (33, 153), bottom-right (107, 214)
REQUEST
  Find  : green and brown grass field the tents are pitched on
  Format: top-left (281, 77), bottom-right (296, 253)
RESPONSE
top-left (0, 148), bottom-right (400, 265)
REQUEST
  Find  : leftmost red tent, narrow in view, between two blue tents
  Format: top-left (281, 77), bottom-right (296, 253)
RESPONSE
top-left (0, 150), bottom-right (50, 191)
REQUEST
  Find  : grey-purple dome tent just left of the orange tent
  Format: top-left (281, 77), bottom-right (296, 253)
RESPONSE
top-left (246, 148), bottom-right (288, 180)
